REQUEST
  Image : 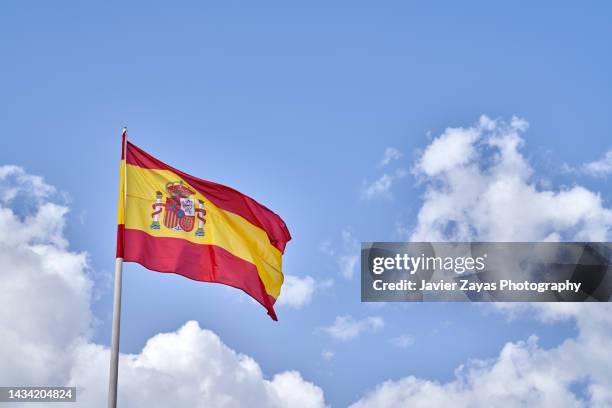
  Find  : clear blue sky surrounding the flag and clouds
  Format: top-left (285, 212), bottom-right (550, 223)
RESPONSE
top-left (0, 1), bottom-right (612, 406)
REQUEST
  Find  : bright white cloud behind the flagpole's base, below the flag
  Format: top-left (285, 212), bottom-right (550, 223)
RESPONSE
top-left (70, 321), bottom-right (324, 407)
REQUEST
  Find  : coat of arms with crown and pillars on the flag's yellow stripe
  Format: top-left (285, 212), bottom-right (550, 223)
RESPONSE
top-left (151, 181), bottom-right (206, 236)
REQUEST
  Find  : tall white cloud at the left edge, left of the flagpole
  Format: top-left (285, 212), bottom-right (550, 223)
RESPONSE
top-left (0, 178), bottom-right (92, 384)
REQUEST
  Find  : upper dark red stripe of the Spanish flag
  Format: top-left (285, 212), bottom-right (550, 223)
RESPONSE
top-left (126, 142), bottom-right (291, 253)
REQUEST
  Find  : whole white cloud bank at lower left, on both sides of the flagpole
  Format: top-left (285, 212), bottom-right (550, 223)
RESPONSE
top-left (0, 166), bottom-right (325, 407)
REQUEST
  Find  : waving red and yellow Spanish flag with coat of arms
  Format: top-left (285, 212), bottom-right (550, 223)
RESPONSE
top-left (117, 130), bottom-right (291, 320)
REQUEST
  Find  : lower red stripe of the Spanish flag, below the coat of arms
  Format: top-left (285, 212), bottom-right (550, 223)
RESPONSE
top-left (123, 229), bottom-right (278, 320)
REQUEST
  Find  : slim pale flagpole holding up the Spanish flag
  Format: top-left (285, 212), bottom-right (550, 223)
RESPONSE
top-left (108, 128), bottom-right (127, 408)
